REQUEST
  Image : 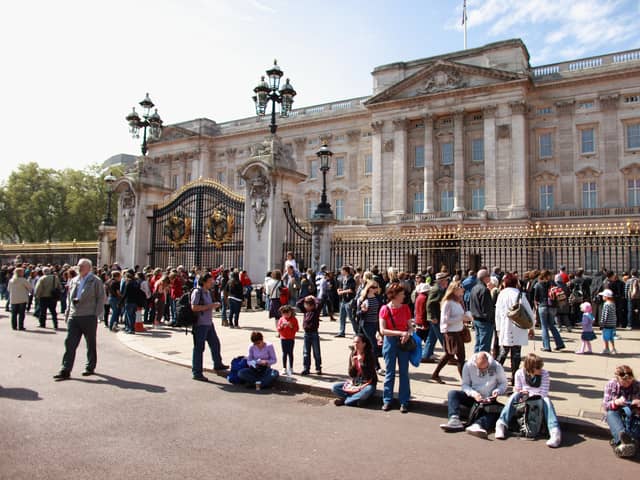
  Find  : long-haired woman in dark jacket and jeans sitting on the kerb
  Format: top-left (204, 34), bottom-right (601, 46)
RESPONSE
top-left (332, 333), bottom-right (378, 407)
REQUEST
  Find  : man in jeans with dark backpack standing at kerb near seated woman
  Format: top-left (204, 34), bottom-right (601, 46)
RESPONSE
top-left (191, 273), bottom-right (229, 382)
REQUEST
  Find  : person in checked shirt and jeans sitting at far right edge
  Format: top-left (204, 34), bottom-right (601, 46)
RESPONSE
top-left (602, 365), bottom-right (640, 457)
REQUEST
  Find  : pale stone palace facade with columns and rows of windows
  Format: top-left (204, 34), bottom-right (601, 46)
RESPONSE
top-left (134, 39), bottom-right (640, 270)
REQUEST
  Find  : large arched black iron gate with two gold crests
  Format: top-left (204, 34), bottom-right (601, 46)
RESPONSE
top-left (149, 180), bottom-right (244, 268)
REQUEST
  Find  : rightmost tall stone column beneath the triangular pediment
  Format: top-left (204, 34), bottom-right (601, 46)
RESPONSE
top-left (510, 102), bottom-right (529, 218)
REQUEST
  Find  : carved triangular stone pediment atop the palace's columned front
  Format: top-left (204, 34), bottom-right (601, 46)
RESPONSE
top-left (365, 60), bottom-right (528, 106)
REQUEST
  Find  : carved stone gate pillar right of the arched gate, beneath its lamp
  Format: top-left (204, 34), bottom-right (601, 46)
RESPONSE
top-left (238, 135), bottom-right (307, 281)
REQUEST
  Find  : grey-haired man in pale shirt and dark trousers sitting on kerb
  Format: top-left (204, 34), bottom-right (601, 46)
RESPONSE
top-left (440, 352), bottom-right (507, 438)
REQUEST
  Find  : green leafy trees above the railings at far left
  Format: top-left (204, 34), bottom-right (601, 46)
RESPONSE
top-left (0, 163), bottom-right (122, 242)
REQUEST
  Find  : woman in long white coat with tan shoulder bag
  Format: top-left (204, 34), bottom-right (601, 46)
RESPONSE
top-left (496, 273), bottom-right (534, 385)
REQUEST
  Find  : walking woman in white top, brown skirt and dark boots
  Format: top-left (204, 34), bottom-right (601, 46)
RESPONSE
top-left (431, 281), bottom-right (466, 383)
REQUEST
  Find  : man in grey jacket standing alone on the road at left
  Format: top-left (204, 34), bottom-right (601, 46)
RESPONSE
top-left (53, 258), bottom-right (104, 381)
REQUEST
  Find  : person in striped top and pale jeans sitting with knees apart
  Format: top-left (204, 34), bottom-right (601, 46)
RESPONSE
top-left (496, 353), bottom-right (562, 448)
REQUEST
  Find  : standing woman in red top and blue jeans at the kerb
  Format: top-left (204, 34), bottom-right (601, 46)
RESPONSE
top-left (379, 283), bottom-right (412, 413)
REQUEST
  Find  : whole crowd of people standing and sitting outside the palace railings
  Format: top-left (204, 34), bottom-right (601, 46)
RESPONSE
top-left (0, 252), bottom-right (640, 456)
